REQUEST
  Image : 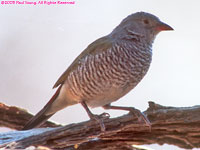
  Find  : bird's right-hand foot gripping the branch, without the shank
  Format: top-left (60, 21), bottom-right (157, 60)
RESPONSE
top-left (129, 108), bottom-right (151, 131)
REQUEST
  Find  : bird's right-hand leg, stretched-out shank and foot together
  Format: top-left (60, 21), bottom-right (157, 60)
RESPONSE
top-left (103, 104), bottom-right (151, 131)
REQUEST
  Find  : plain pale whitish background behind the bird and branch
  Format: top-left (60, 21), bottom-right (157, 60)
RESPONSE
top-left (0, 0), bottom-right (200, 150)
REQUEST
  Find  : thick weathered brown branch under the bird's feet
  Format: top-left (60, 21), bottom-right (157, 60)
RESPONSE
top-left (0, 102), bottom-right (200, 150)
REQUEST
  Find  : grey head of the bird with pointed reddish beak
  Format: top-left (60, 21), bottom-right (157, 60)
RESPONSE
top-left (110, 12), bottom-right (173, 43)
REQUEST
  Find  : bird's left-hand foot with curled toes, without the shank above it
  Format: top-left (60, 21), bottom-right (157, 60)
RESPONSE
top-left (90, 113), bottom-right (110, 132)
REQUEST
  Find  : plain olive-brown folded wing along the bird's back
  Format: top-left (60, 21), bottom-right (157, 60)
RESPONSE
top-left (53, 36), bottom-right (112, 88)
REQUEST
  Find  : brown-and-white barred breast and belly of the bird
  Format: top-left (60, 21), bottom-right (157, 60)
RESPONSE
top-left (65, 39), bottom-right (151, 107)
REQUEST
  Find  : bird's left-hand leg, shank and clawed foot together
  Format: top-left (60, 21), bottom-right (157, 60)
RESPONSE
top-left (81, 101), bottom-right (110, 131)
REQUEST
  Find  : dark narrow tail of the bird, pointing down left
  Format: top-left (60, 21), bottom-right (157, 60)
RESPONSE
top-left (22, 86), bottom-right (62, 130)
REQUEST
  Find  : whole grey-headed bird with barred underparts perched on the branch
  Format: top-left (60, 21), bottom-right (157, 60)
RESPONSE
top-left (22, 11), bottom-right (173, 131)
